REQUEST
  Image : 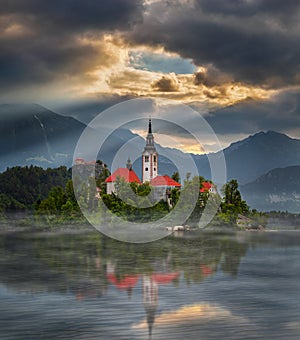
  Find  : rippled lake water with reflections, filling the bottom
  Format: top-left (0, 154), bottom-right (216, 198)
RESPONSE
top-left (0, 230), bottom-right (300, 340)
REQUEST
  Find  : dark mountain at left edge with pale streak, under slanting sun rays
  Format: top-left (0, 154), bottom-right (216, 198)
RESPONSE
top-left (0, 104), bottom-right (85, 171)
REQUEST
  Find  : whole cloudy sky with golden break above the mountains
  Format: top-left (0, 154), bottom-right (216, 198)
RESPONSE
top-left (0, 0), bottom-right (300, 151)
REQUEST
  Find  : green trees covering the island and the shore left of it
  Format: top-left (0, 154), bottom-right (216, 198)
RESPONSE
top-left (0, 161), bottom-right (260, 230)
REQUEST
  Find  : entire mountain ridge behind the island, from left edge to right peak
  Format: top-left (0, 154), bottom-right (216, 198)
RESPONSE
top-left (0, 104), bottom-right (300, 190)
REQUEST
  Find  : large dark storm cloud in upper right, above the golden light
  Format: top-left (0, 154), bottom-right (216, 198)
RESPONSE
top-left (129, 0), bottom-right (300, 87)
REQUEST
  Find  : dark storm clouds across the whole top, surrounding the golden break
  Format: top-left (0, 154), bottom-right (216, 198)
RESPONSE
top-left (0, 0), bottom-right (300, 97)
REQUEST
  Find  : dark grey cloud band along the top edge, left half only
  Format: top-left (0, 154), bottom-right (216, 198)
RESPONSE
top-left (0, 0), bottom-right (142, 32)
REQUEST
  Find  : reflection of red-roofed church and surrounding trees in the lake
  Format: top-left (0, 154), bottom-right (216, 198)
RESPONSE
top-left (0, 233), bottom-right (248, 339)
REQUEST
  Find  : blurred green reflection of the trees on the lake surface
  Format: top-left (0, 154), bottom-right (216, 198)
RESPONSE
top-left (0, 232), bottom-right (247, 298)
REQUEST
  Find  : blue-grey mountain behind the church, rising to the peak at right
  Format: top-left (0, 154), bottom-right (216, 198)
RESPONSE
top-left (102, 131), bottom-right (300, 189)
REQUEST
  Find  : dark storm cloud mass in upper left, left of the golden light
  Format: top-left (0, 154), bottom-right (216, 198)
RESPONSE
top-left (0, 0), bottom-right (142, 90)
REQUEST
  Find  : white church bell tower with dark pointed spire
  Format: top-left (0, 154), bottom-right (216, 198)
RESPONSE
top-left (142, 118), bottom-right (158, 183)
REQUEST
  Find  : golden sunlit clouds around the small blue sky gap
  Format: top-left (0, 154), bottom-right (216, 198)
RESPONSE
top-left (79, 35), bottom-right (276, 106)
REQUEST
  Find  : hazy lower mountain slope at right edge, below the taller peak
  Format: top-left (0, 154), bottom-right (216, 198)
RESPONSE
top-left (240, 166), bottom-right (300, 213)
